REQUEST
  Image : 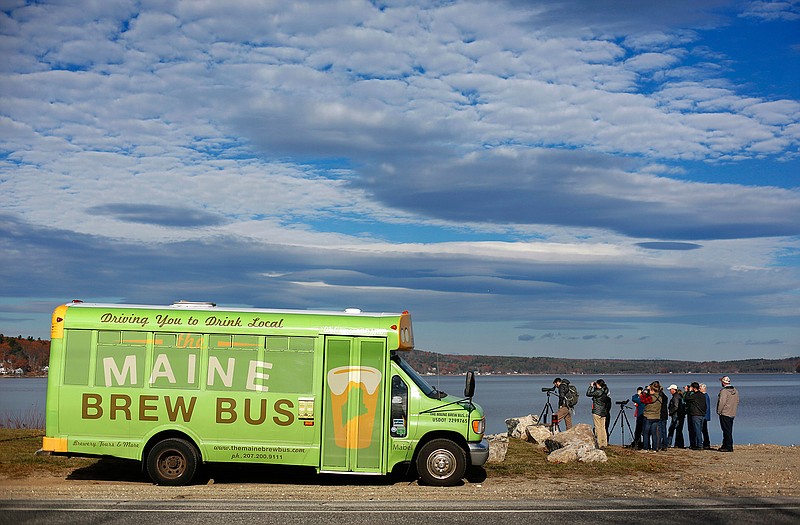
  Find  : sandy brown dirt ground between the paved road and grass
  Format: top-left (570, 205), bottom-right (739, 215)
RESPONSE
top-left (0, 445), bottom-right (800, 501)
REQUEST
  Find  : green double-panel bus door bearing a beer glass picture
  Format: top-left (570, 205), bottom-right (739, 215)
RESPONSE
top-left (321, 337), bottom-right (387, 473)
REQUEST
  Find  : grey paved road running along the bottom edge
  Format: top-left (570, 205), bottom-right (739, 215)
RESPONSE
top-left (0, 498), bottom-right (800, 525)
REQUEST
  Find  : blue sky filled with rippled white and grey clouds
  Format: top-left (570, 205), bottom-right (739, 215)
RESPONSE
top-left (0, 0), bottom-right (800, 361)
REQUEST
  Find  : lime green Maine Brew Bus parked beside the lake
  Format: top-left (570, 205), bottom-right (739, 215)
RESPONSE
top-left (42, 301), bottom-right (489, 486)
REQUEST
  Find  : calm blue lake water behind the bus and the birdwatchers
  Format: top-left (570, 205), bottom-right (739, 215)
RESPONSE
top-left (0, 374), bottom-right (800, 445)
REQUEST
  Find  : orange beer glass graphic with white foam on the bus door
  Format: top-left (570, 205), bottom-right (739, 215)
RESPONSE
top-left (328, 366), bottom-right (381, 448)
